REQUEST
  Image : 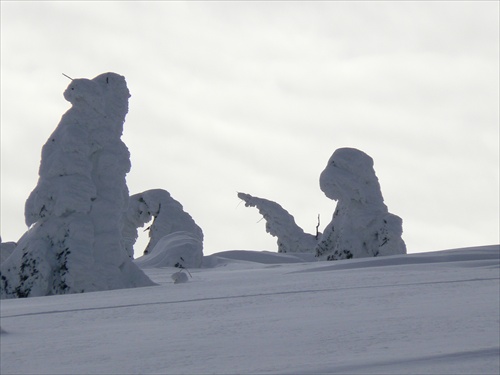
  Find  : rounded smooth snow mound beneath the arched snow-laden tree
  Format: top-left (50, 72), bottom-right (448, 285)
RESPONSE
top-left (134, 231), bottom-right (203, 268)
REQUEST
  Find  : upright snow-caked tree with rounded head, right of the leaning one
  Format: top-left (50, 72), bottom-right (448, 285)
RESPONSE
top-left (316, 148), bottom-right (406, 260)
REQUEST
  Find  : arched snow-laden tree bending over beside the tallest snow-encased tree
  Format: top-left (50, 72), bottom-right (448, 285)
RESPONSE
top-left (123, 189), bottom-right (203, 257)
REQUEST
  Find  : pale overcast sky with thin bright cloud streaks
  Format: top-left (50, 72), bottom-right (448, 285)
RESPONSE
top-left (0, 1), bottom-right (500, 254)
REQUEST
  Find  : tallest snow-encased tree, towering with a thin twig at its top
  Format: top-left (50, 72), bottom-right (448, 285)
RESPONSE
top-left (1, 73), bottom-right (154, 298)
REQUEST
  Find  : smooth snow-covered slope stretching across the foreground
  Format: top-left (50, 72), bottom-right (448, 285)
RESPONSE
top-left (0, 245), bottom-right (500, 374)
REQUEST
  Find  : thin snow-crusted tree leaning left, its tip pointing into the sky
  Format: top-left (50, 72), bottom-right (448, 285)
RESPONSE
top-left (238, 193), bottom-right (317, 253)
